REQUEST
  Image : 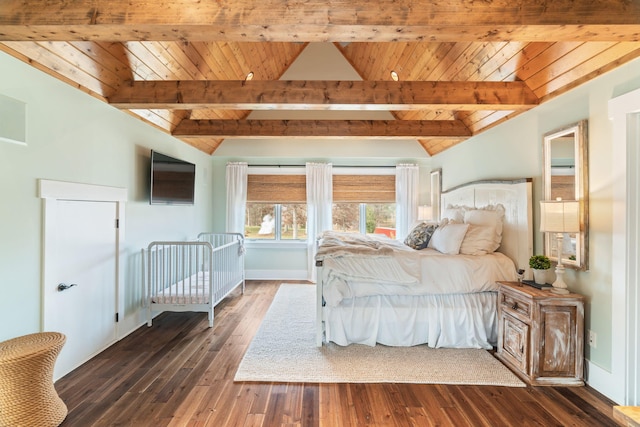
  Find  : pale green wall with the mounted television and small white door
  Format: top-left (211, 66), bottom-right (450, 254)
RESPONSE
top-left (0, 53), bottom-right (213, 340)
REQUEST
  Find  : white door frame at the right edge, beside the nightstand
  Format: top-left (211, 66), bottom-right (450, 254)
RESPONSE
top-left (603, 89), bottom-right (640, 405)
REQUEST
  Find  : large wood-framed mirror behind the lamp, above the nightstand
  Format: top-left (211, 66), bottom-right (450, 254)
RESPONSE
top-left (542, 120), bottom-right (589, 270)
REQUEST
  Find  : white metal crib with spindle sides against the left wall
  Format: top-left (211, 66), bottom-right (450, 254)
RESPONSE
top-left (142, 233), bottom-right (245, 327)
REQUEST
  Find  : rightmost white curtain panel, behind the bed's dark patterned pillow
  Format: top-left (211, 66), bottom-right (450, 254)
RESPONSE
top-left (396, 164), bottom-right (420, 240)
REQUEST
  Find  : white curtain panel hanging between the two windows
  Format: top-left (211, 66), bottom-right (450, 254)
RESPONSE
top-left (306, 163), bottom-right (333, 283)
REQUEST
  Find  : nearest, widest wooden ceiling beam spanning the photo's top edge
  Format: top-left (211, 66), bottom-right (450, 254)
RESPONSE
top-left (0, 0), bottom-right (640, 42)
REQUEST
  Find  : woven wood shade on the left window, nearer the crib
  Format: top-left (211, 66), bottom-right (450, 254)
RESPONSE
top-left (247, 175), bottom-right (307, 203)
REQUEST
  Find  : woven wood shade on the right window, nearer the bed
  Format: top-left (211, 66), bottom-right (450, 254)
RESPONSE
top-left (333, 175), bottom-right (396, 203)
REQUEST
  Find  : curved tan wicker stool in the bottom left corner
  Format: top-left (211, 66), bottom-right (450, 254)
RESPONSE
top-left (0, 332), bottom-right (67, 427)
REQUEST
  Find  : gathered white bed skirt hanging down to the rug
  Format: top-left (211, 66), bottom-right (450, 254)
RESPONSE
top-left (323, 292), bottom-right (498, 349)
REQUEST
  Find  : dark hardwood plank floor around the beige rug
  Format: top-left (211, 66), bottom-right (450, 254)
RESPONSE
top-left (56, 281), bottom-right (618, 427)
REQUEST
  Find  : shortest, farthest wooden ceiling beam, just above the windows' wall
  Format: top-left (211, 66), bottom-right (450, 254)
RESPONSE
top-left (172, 120), bottom-right (471, 139)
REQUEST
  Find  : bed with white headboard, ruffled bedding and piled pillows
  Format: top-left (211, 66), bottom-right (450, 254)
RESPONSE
top-left (316, 180), bottom-right (533, 349)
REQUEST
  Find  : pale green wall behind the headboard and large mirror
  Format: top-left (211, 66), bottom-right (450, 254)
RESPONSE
top-left (431, 56), bottom-right (640, 371)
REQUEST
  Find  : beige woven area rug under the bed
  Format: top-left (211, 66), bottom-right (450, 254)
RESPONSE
top-left (235, 284), bottom-right (525, 387)
